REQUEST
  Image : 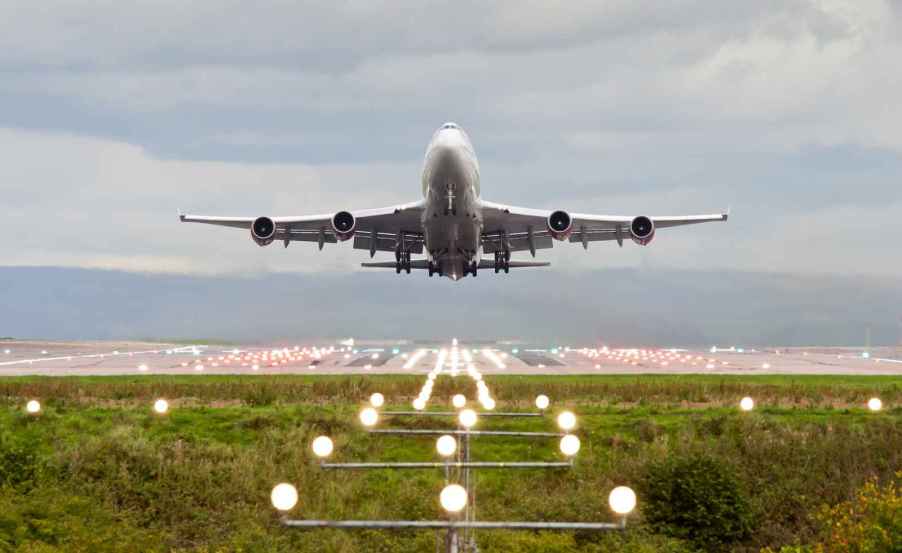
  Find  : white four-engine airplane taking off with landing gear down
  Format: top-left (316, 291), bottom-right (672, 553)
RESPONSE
top-left (179, 123), bottom-right (729, 281)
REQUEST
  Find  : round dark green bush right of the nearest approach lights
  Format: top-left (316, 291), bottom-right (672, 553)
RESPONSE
top-left (640, 455), bottom-right (752, 551)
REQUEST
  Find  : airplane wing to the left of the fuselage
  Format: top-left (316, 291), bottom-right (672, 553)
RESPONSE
top-left (179, 200), bottom-right (425, 253)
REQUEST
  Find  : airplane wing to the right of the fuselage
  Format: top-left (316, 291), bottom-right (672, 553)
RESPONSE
top-left (482, 201), bottom-right (729, 255)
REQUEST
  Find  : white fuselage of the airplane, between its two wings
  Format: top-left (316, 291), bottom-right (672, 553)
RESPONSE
top-left (422, 123), bottom-right (482, 280)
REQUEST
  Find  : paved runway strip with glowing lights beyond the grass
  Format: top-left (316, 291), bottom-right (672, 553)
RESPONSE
top-left (0, 339), bottom-right (902, 376)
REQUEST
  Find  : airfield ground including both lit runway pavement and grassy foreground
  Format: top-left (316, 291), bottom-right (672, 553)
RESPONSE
top-left (0, 341), bottom-right (902, 553)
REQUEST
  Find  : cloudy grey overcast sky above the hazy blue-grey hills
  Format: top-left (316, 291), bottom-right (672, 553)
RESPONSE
top-left (0, 0), bottom-right (902, 276)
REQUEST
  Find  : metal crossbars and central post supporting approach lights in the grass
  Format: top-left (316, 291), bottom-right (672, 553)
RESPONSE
top-left (282, 411), bottom-right (626, 553)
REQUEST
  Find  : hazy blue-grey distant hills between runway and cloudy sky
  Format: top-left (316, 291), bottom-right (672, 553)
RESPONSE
top-left (0, 267), bottom-right (902, 345)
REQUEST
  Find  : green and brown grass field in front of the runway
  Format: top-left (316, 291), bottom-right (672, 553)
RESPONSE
top-left (0, 376), bottom-right (902, 552)
